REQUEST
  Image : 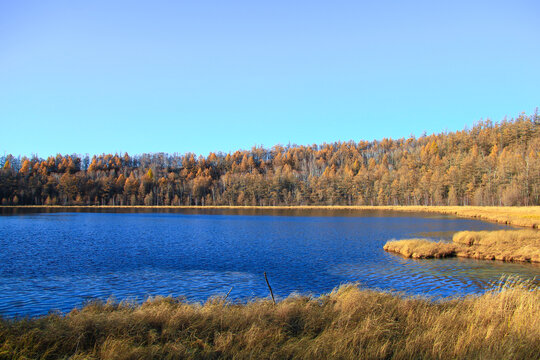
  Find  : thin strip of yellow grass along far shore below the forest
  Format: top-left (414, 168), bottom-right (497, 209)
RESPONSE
top-left (4, 205), bottom-right (540, 229)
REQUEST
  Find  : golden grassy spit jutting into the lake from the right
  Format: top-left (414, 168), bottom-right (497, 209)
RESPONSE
top-left (384, 230), bottom-right (540, 263)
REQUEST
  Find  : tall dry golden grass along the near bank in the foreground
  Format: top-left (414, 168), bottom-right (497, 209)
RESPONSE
top-left (0, 283), bottom-right (540, 359)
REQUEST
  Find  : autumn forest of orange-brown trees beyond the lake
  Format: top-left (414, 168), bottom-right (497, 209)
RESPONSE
top-left (0, 111), bottom-right (540, 206)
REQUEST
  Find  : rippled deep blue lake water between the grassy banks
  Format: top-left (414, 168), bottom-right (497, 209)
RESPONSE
top-left (0, 210), bottom-right (540, 317)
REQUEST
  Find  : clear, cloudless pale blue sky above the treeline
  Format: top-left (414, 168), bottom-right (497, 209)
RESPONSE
top-left (0, 0), bottom-right (540, 157)
